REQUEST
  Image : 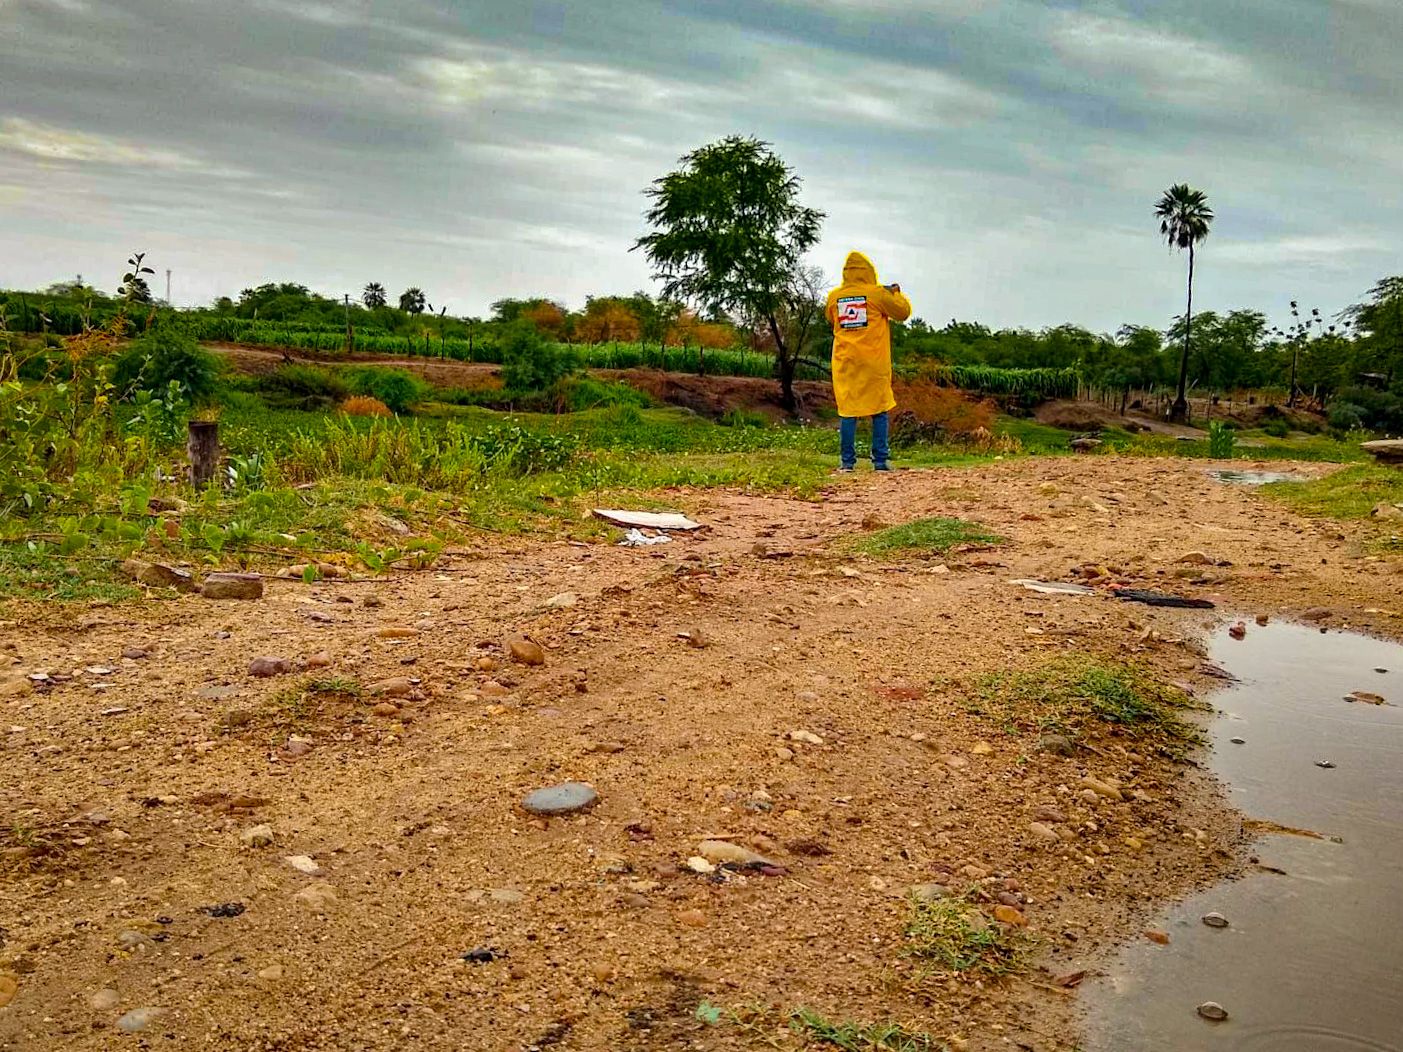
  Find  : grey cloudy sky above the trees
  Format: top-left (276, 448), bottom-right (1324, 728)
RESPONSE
top-left (0, 0), bottom-right (1403, 330)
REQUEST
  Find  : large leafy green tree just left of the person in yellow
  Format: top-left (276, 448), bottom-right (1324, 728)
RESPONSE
top-left (634, 136), bottom-right (824, 410)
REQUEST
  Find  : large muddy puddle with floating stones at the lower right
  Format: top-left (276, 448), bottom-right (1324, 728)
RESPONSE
top-left (1085, 624), bottom-right (1403, 1052)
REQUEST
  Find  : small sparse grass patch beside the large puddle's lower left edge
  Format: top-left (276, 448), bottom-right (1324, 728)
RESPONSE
top-left (905, 896), bottom-right (1033, 978)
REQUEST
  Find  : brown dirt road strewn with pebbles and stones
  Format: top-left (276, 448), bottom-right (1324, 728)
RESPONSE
top-left (0, 457), bottom-right (1400, 1052)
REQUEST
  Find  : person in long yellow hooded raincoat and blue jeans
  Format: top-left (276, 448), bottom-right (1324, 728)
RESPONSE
top-left (825, 252), bottom-right (911, 471)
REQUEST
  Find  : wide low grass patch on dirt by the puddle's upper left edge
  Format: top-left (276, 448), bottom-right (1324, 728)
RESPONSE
top-left (971, 654), bottom-right (1202, 756)
